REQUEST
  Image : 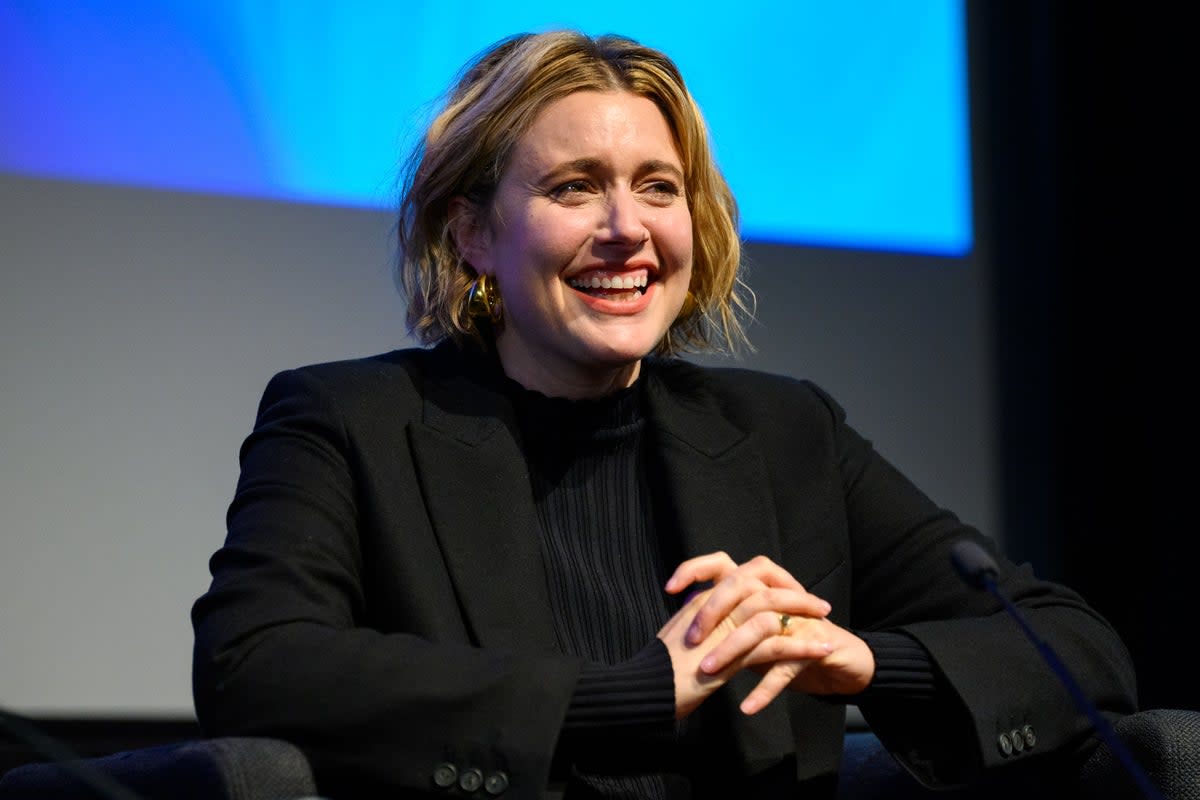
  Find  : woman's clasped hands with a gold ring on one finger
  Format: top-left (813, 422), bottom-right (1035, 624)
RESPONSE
top-left (658, 553), bottom-right (875, 720)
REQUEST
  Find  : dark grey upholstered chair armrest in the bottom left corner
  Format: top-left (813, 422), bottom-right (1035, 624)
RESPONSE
top-left (0, 736), bottom-right (317, 800)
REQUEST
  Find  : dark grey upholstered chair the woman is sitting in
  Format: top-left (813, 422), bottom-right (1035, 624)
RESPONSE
top-left (0, 709), bottom-right (1200, 800)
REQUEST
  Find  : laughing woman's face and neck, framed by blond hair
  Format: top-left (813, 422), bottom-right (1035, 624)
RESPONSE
top-left (464, 91), bottom-right (692, 397)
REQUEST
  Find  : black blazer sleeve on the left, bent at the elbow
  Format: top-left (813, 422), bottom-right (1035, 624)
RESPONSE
top-left (192, 371), bottom-right (580, 798)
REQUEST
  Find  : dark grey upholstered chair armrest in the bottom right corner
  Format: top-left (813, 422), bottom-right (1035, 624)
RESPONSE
top-left (1080, 709), bottom-right (1200, 800)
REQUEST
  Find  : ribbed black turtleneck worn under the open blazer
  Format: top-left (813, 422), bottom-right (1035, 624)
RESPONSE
top-left (509, 381), bottom-right (676, 798)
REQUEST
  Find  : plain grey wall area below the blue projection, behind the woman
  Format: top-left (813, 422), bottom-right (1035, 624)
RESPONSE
top-left (0, 175), bottom-right (998, 716)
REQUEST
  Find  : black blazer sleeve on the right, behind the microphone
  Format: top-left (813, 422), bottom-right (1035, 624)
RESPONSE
top-left (814, 387), bottom-right (1136, 787)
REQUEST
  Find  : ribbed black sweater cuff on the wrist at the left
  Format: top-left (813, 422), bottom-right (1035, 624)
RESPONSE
top-left (563, 638), bottom-right (676, 732)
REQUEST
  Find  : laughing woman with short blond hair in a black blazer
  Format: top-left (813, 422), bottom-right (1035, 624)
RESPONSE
top-left (193, 32), bottom-right (1134, 798)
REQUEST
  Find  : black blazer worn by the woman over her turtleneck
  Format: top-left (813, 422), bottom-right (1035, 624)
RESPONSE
top-left (193, 345), bottom-right (1135, 799)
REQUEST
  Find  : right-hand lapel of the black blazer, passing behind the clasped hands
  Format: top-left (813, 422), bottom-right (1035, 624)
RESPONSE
top-left (643, 362), bottom-right (796, 774)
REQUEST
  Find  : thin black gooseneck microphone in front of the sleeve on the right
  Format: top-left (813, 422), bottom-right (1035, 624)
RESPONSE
top-left (950, 539), bottom-right (1165, 800)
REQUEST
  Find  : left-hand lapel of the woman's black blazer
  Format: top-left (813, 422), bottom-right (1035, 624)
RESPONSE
top-left (400, 352), bottom-right (556, 650)
